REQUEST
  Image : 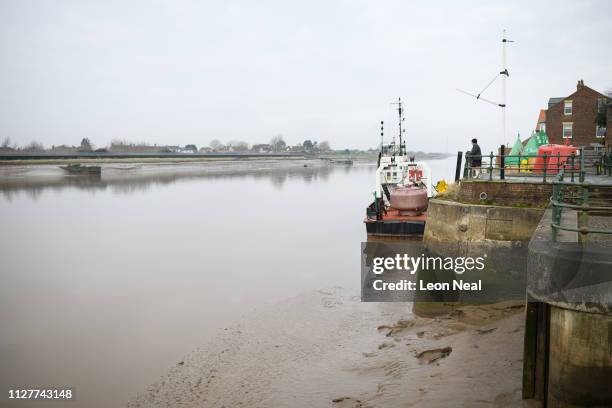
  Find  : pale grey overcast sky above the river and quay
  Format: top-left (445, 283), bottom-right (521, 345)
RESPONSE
top-left (0, 0), bottom-right (612, 152)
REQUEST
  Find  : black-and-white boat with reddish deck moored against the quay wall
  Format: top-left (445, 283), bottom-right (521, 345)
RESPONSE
top-left (364, 98), bottom-right (435, 238)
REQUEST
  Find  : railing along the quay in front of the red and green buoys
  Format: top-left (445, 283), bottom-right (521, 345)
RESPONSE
top-left (455, 148), bottom-right (586, 183)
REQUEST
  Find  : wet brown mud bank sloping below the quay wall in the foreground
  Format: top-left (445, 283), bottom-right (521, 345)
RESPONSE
top-left (128, 288), bottom-right (524, 408)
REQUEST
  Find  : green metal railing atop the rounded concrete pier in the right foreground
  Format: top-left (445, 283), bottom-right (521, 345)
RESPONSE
top-left (550, 170), bottom-right (612, 242)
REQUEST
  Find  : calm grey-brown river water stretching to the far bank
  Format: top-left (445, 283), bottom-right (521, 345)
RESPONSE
top-left (0, 158), bottom-right (454, 407)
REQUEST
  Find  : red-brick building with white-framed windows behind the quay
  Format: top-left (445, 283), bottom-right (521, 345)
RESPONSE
top-left (546, 80), bottom-right (612, 146)
